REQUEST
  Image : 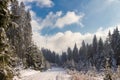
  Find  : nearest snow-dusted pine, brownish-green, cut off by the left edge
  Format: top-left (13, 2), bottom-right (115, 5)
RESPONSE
top-left (0, 0), bottom-right (16, 80)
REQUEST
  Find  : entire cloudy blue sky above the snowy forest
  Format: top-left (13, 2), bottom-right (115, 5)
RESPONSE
top-left (19, 0), bottom-right (120, 53)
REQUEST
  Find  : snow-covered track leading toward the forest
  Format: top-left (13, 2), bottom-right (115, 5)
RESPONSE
top-left (13, 67), bottom-right (71, 80)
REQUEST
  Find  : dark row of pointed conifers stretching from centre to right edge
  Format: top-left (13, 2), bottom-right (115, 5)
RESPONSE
top-left (41, 27), bottom-right (120, 71)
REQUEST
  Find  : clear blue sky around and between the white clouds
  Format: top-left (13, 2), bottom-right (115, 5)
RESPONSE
top-left (24, 0), bottom-right (120, 34)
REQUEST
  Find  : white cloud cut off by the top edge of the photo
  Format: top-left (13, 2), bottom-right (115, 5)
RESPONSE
top-left (19, 0), bottom-right (54, 7)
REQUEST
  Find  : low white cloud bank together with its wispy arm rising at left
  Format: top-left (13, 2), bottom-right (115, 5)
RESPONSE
top-left (30, 11), bottom-right (120, 53)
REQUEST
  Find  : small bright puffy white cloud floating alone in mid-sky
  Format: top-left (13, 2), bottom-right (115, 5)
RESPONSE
top-left (55, 11), bottom-right (84, 28)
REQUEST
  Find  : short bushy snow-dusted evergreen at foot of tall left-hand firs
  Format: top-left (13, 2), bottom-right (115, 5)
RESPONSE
top-left (25, 45), bottom-right (46, 70)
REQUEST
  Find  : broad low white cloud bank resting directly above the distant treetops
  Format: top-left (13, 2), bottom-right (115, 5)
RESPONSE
top-left (33, 25), bottom-right (120, 53)
